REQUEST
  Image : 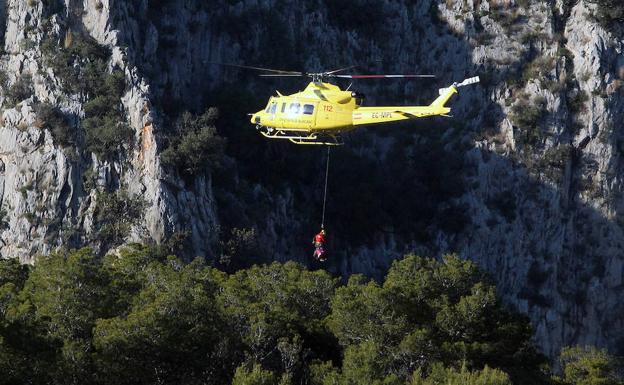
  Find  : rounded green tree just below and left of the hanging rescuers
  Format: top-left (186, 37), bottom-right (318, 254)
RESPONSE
top-left (219, 262), bottom-right (337, 382)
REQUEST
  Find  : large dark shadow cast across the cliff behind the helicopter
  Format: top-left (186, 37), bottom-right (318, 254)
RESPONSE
top-left (122, 1), bottom-right (624, 354)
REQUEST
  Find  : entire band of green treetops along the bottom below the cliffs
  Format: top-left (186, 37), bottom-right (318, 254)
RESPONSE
top-left (0, 250), bottom-right (584, 385)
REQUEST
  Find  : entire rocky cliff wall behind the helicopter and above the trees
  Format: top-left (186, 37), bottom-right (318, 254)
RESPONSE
top-left (0, 0), bottom-right (624, 355)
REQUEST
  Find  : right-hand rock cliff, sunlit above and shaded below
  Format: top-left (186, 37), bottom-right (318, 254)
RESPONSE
top-left (441, 2), bottom-right (623, 355)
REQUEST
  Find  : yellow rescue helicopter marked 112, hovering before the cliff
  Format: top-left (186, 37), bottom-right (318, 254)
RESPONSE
top-left (236, 64), bottom-right (479, 145)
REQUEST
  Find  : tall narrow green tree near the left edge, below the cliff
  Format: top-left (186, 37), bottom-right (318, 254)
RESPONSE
top-left (13, 248), bottom-right (110, 383)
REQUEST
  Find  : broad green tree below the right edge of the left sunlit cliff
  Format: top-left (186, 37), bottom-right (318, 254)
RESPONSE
top-left (93, 250), bottom-right (239, 384)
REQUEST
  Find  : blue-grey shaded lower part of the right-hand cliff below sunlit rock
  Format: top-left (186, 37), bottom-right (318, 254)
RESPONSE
top-left (456, 140), bottom-right (624, 357)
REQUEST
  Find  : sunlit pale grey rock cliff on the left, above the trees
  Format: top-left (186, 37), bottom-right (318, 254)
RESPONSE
top-left (0, 1), bottom-right (216, 262)
